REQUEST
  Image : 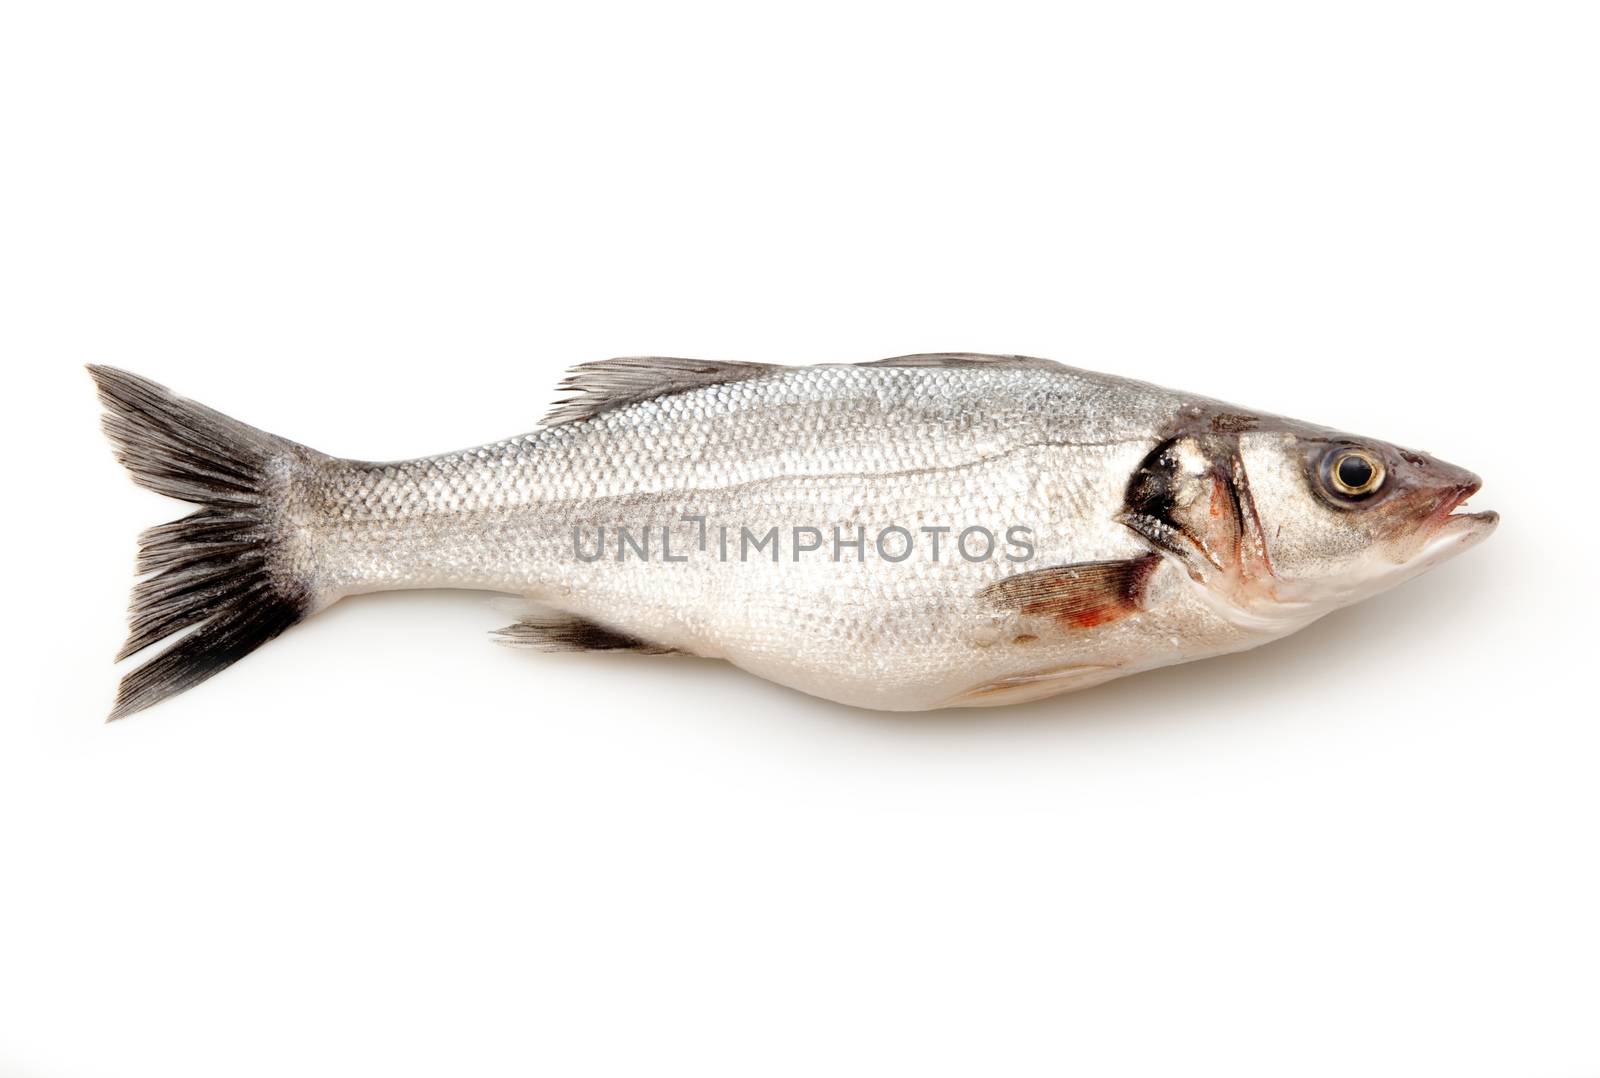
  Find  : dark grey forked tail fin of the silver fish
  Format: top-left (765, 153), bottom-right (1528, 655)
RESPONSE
top-left (90, 366), bottom-right (320, 718)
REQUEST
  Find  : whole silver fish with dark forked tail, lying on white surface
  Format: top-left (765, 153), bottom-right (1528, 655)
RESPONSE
top-left (90, 353), bottom-right (1498, 718)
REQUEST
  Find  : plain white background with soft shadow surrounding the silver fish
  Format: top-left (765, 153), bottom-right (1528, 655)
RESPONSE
top-left (0, 0), bottom-right (1600, 1078)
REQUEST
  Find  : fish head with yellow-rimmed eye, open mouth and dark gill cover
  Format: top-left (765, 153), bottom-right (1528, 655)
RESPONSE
top-left (1123, 417), bottom-right (1499, 632)
